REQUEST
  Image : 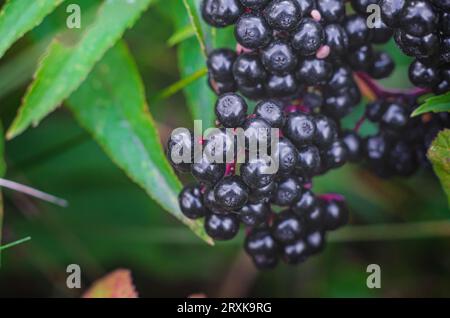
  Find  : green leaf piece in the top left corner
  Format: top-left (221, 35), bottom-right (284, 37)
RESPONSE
top-left (0, 0), bottom-right (64, 58)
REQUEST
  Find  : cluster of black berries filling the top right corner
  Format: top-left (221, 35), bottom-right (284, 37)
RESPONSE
top-left (380, 0), bottom-right (450, 94)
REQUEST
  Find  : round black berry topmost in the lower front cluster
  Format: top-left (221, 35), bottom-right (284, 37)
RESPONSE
top-left (216, 93), bottom-right (248, 128)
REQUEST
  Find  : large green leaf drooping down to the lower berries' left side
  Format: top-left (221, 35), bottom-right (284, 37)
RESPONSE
top-left (68, 44), bottom-right (212, 244)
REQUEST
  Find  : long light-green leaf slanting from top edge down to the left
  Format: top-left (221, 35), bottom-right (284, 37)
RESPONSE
top-left (7, 0), bottom-right (153, 139)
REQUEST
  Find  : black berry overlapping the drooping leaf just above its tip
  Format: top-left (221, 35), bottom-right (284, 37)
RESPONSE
top-left (178, 185), bottom-right (208, 219)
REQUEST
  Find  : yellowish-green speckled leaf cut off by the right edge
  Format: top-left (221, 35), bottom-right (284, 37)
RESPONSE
top-left (428, 129), bottom-right (450, 206)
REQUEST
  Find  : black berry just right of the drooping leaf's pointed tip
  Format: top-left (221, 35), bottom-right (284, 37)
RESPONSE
top-left (205, 213), bottom-right (239, 241)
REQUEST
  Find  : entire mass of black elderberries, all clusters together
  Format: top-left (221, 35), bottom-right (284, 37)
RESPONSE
top-left (168, 0), bottom-right (450, 269)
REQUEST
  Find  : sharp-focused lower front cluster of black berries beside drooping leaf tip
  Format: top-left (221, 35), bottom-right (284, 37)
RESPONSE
top-left (168, 93), bottom-right (348, 268)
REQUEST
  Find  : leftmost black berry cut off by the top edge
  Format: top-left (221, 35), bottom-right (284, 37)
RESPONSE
top-left (201, 0), bottom-right (243, 28)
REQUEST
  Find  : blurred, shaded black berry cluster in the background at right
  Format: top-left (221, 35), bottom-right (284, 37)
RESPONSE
top-left (364, 98), bottom-right (450, 178)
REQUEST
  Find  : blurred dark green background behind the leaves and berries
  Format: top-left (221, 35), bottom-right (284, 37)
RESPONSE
top-left (0, 0), bottom-right (450, 297)
